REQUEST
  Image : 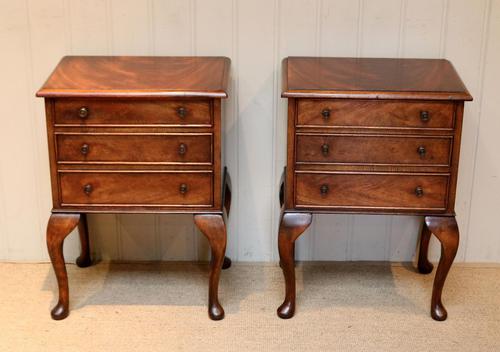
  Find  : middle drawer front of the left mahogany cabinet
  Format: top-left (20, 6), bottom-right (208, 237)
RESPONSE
top-left (56, 133), bottom-right (213, 165)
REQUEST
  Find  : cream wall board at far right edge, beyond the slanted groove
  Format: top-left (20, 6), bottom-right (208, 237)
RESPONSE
top-left (465, 0), bottom-right (500, 262)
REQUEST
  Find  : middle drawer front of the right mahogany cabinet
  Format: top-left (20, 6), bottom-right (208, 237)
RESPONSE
top-left (296, 134), bottom-right (452, 166)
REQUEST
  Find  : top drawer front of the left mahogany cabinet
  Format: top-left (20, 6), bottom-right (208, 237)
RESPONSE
top-left (55, 99), bottom-right (212, 126)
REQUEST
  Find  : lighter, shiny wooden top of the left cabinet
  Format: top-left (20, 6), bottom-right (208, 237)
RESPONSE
top-left (37, 56), bottom-right (230, 98)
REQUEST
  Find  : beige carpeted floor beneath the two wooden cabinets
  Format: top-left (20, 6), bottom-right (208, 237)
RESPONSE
top-left (0, 263), bottom-right (500, 352)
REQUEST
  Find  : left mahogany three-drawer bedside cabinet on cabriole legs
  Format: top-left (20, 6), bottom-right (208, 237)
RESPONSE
top-left (37, 56), bottom-right (231, 320)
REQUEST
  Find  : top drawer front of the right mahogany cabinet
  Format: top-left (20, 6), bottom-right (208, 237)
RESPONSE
top-left (297, 99), bottom-right (454, 129)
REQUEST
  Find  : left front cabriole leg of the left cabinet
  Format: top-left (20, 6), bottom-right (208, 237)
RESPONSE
top-left (47, 214), bottom-right (80, 320)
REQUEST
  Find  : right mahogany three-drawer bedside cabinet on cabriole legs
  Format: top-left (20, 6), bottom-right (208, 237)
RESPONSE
top-left (278, 57), bottom-right (472, 320)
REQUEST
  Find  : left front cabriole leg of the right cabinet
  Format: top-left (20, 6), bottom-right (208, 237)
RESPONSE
top-left (278, 213), bottom-right (312, 319)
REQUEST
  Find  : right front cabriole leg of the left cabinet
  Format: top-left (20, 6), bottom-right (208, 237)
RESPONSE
top-left (194, 214), bottom-right (226, 320)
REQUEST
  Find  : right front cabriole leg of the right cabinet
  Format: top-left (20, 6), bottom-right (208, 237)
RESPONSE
top-left (425, 216), bottom-right (459, 321)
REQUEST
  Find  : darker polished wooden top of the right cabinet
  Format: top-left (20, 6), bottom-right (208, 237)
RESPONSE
top-left (282, 57), bottom-right (472, 100)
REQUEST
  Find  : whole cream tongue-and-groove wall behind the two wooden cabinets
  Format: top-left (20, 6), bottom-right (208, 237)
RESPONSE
top-left (0, 0), bottom-right (500, 262)
